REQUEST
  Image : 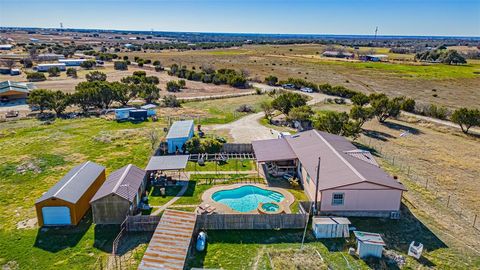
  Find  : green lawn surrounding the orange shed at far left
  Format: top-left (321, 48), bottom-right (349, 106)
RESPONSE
top-left (0, 118), bottom-right (162, 269)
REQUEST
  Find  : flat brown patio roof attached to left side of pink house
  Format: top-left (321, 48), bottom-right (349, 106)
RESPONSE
top-left (252, 138), bottom-right (297, 162)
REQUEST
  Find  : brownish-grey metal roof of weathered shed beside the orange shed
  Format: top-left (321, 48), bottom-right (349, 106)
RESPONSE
top-left (90, 164), bottom-right (145, 203)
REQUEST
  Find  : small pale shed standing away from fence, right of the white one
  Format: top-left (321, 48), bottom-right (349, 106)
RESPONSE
top-left (353, 231), bottom-right (385, 259)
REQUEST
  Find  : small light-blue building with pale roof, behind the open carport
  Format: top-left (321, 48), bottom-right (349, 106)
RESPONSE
top-left (167, 120), bottom-right (194, 154)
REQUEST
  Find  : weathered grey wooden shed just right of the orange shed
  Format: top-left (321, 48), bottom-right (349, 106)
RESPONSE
top-left (90, 164), bottom-right (146, 224)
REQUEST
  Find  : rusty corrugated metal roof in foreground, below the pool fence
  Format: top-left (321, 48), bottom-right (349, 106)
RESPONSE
top-left (138, 209), bottom-right (197, 270)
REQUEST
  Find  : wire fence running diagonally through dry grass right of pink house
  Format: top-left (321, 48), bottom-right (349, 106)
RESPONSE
top-left (359, 137), bottom-right (480, 231)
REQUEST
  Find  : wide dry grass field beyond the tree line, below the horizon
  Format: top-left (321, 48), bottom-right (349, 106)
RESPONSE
top-left (122, 44), bottom-right (480, 108)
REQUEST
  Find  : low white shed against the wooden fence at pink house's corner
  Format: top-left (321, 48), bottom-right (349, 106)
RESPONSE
top-left (312, 217), bottom-right (351, 238)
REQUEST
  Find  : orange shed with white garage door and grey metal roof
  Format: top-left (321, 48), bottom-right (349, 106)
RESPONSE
top-left (35, 161), bottom-right (105, 226)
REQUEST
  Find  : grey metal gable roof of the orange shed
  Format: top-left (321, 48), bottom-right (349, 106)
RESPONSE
top-left (36, 161), bottom-right (105, 204)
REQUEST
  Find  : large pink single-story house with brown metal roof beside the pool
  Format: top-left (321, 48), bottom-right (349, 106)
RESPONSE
top-left (252, 130), bottom-right (406, 217)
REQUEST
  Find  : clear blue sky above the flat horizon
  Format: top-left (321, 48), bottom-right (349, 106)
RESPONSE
top-left (0, 0), bottom-right (480, 36)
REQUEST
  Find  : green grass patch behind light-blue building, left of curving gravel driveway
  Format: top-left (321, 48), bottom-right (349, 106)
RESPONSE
top-left (182, 95), bottom-right (271, 125)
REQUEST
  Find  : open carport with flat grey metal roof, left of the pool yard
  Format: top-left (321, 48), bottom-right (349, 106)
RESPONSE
top-left (145, 155), bottom-right (189, 184)
